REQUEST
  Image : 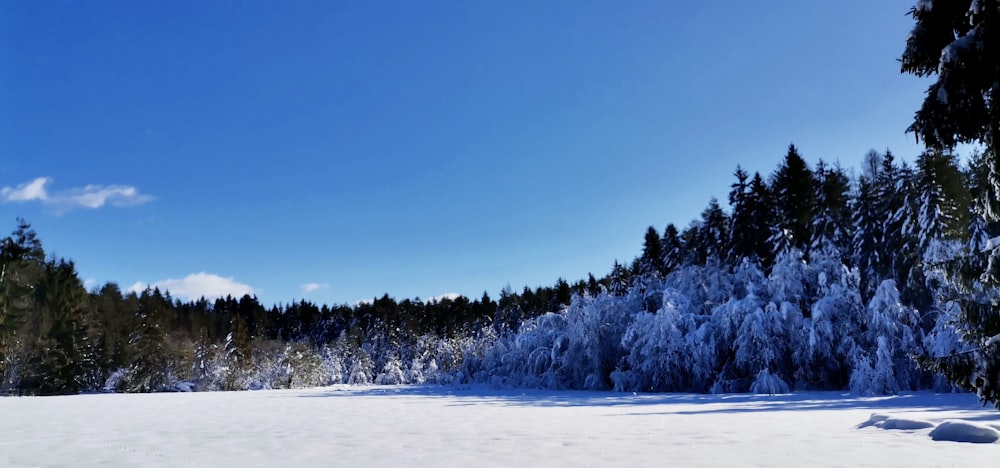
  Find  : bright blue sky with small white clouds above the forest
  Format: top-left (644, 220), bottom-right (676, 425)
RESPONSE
top-left (0, 0), bottom-right (929, 304)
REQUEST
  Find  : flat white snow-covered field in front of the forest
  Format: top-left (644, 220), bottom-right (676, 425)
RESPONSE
top-left (0, 386), bottom-right (1000, 468)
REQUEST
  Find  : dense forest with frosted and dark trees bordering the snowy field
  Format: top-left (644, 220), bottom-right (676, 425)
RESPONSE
top-left (0, 145), bottom-right (1000, 395)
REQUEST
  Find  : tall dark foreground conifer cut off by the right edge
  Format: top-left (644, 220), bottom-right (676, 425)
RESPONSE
top-left (901, 0), bottom-right (1000, 407)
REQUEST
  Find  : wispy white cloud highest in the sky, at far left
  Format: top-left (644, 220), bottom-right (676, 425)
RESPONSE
top-left (0, 177), bottom-right (154, 212)
